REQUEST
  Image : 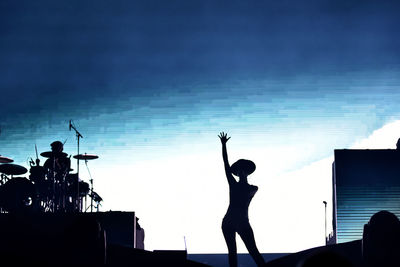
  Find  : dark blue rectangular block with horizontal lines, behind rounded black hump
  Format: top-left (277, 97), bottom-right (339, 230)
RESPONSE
top-left (327, 149), bottom-right (400, 243)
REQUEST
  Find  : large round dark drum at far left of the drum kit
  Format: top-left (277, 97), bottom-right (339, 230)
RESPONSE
top-left (0, 177), bottom-right (37, 213)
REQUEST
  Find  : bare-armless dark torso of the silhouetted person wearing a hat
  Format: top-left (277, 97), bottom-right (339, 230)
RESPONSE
top-left (225, 182), bottom-right (258, 222)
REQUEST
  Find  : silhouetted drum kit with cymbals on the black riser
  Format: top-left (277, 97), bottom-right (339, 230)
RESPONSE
top-left (0, 149), bottom-right (103, 216)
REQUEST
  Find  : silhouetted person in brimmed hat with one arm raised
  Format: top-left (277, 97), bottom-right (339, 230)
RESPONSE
top-left (219, 132), bottom-right (265, 267)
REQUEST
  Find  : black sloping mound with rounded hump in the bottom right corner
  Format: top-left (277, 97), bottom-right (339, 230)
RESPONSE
top-left (266, 211), bottom-right (400, 267)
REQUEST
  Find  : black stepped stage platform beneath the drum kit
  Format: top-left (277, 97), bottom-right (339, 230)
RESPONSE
top-left (0, 212), bottom-right (211, 267)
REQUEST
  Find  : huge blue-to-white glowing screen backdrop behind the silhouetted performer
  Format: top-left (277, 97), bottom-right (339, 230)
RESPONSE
top-left (0, 1), bottom-right (400, 253)
